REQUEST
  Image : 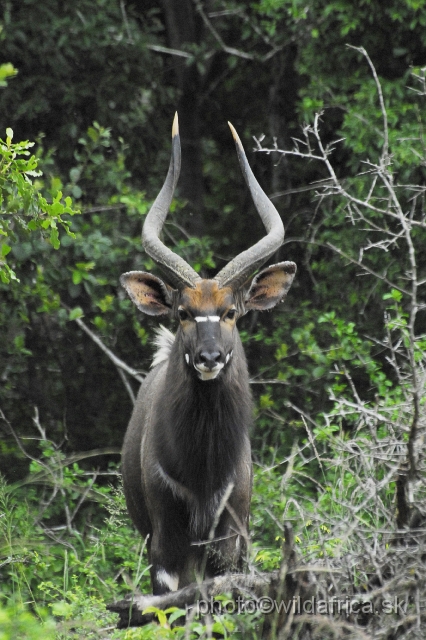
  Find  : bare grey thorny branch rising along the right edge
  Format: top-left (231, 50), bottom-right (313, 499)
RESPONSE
top-left (255, 47), bottom-right (426, 527)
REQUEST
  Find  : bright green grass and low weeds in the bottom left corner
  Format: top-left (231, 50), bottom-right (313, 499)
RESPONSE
top-left (0, 440), bottom-right (147, 639)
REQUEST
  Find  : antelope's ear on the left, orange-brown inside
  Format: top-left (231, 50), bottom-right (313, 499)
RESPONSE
top-left (120, 271), bottom-right (175, 316)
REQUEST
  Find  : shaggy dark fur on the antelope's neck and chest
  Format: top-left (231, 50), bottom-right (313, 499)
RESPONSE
top-left (156, 332), bottom-right (252, 500)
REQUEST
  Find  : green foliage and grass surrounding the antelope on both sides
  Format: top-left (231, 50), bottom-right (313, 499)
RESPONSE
top-left (0, 0), bottom-right (426, 640)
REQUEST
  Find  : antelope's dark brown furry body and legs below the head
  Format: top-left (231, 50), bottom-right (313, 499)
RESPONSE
top-left (123, 320), bottom-right (252, 593)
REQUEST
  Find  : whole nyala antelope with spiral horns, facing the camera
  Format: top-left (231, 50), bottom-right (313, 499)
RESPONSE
top-left (120, 114), bottom-right (296, 595)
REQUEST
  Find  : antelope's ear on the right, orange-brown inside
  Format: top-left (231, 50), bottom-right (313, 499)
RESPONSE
top-left (244, 262), bottom-right (297, 311)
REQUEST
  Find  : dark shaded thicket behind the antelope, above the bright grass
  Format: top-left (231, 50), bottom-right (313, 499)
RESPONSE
top-left (0, 0), bottom-right (426, 638)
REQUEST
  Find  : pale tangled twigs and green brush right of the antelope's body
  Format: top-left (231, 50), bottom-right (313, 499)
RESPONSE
top-left (251, 308), bottom-right (424, 580)
